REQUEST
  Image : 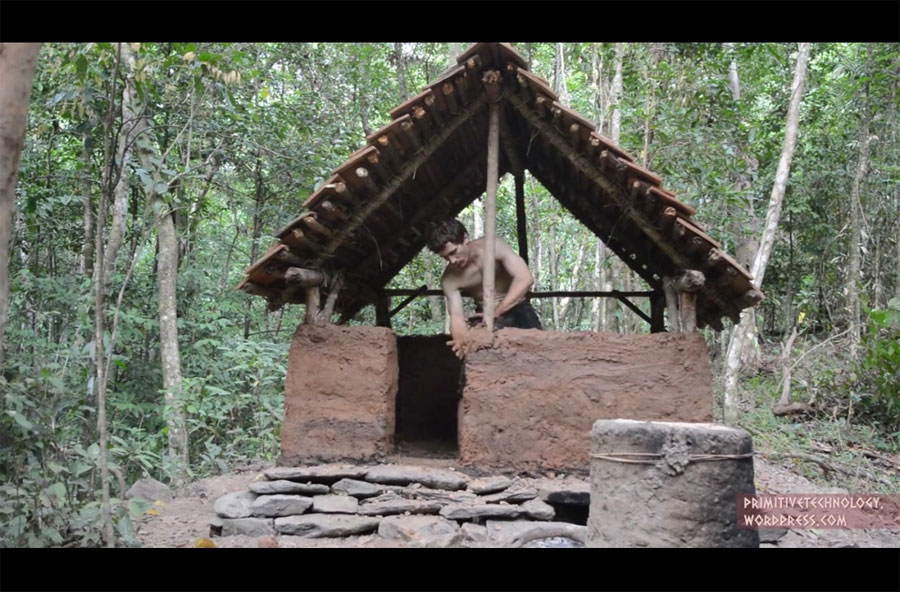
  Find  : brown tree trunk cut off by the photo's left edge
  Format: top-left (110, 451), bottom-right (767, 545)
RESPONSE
top-left (0, 43), bottom-right (40, 371)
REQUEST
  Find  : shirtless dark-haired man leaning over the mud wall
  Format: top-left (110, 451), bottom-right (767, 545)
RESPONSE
top-left (428, 219), bottom-right (543, 358)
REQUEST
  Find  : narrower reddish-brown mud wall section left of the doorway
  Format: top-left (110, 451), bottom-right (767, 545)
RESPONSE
top-left (281, 325), bottom-right (398, 466)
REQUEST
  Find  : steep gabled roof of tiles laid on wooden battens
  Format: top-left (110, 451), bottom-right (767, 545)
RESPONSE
top-left (238, 43), bottom-right (762, 329)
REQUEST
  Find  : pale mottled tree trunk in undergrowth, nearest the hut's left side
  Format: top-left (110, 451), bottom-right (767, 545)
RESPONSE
top-left (154, 199), bottom-right (189, 478)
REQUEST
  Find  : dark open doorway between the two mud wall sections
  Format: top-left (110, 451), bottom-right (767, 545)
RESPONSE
top-left (396, 335), bottom-right (461, 448)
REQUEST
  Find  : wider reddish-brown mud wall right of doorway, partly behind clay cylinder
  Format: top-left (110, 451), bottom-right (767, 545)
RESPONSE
top-left (459, 329), bottom-right (713, 473)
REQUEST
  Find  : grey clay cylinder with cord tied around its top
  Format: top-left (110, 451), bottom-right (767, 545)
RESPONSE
top-left (586, 419), bottom-right (759, 547)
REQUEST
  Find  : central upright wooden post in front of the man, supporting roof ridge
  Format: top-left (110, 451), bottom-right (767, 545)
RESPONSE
top-left (482, 70), bottom-right (500, 331)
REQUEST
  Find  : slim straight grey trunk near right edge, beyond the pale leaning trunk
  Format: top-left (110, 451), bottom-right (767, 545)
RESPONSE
top-left (846, 44), bottom-right (872, 360)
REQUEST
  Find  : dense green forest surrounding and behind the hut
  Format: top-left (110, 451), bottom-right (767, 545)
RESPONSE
top-left (0, 43), bottom-right (900, 546)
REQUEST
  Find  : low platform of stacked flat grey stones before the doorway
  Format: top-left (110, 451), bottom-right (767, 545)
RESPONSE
top-left (212, 463), bottom-right (589, 546)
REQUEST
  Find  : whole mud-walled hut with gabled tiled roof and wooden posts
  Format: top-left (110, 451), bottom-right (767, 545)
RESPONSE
top-left (238, 43), bottom-right (762, 471)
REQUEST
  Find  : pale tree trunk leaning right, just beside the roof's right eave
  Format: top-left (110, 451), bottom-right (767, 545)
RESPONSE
top-left (724, 43), bottom-right (809, 424)
